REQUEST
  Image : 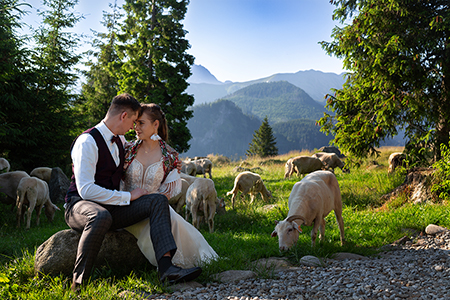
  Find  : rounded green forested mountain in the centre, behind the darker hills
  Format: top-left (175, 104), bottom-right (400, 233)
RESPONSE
top-left (222, 81), bottom-right (326, 124)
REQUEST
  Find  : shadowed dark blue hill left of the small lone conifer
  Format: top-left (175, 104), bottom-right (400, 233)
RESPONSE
top-left (181, 100), bottom-right (261, 158)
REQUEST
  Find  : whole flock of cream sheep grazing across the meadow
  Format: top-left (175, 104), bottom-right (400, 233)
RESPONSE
top-left (0, 147), bottom-right (404, 251)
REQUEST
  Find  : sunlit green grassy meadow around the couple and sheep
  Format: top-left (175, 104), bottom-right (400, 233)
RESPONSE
top-left (0, 147), bottom-right (450, 300)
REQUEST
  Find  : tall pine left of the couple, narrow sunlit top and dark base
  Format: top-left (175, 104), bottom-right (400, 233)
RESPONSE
top-left (0, 0), bottom-right (80, 172)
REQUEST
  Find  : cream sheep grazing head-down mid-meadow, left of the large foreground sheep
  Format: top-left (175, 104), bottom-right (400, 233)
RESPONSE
top-left (227, 171), bottom-right (272, 209)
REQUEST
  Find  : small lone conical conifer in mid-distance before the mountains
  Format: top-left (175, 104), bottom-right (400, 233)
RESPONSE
top-left (247, 116), bottom-right (278, 157)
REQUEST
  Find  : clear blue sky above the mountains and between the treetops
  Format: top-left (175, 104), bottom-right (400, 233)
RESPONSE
top-left (22, 0), bottom-right (343, 82)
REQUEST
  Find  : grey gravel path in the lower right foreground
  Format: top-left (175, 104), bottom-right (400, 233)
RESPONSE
top-left (130, 225), bottom-right (450, 300)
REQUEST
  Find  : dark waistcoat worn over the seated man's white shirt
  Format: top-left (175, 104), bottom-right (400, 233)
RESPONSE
top-left (66, 127), bottom-right (125, 202)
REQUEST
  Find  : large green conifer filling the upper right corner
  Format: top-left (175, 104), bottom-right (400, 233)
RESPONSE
top-left (319, 0), bottom-right (450, 159)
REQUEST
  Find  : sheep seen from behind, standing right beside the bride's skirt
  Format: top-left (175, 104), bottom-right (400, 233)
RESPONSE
top-left (185, 178), bottom-right (217, 233)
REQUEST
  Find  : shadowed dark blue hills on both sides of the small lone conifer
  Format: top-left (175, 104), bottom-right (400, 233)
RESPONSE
top-left (181, 99), bottom-right (331, 159)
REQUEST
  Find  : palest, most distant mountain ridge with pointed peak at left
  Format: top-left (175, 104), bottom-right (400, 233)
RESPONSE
top-left (186, 65), bottom-right (345, 105)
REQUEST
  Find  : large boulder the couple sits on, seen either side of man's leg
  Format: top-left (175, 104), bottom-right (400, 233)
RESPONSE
top-left (34, 229), bottom-right (150, 276)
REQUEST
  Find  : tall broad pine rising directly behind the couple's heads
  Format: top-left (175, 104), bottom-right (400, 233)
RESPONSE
top-left (119, 0), bottom-right (194, 153)
